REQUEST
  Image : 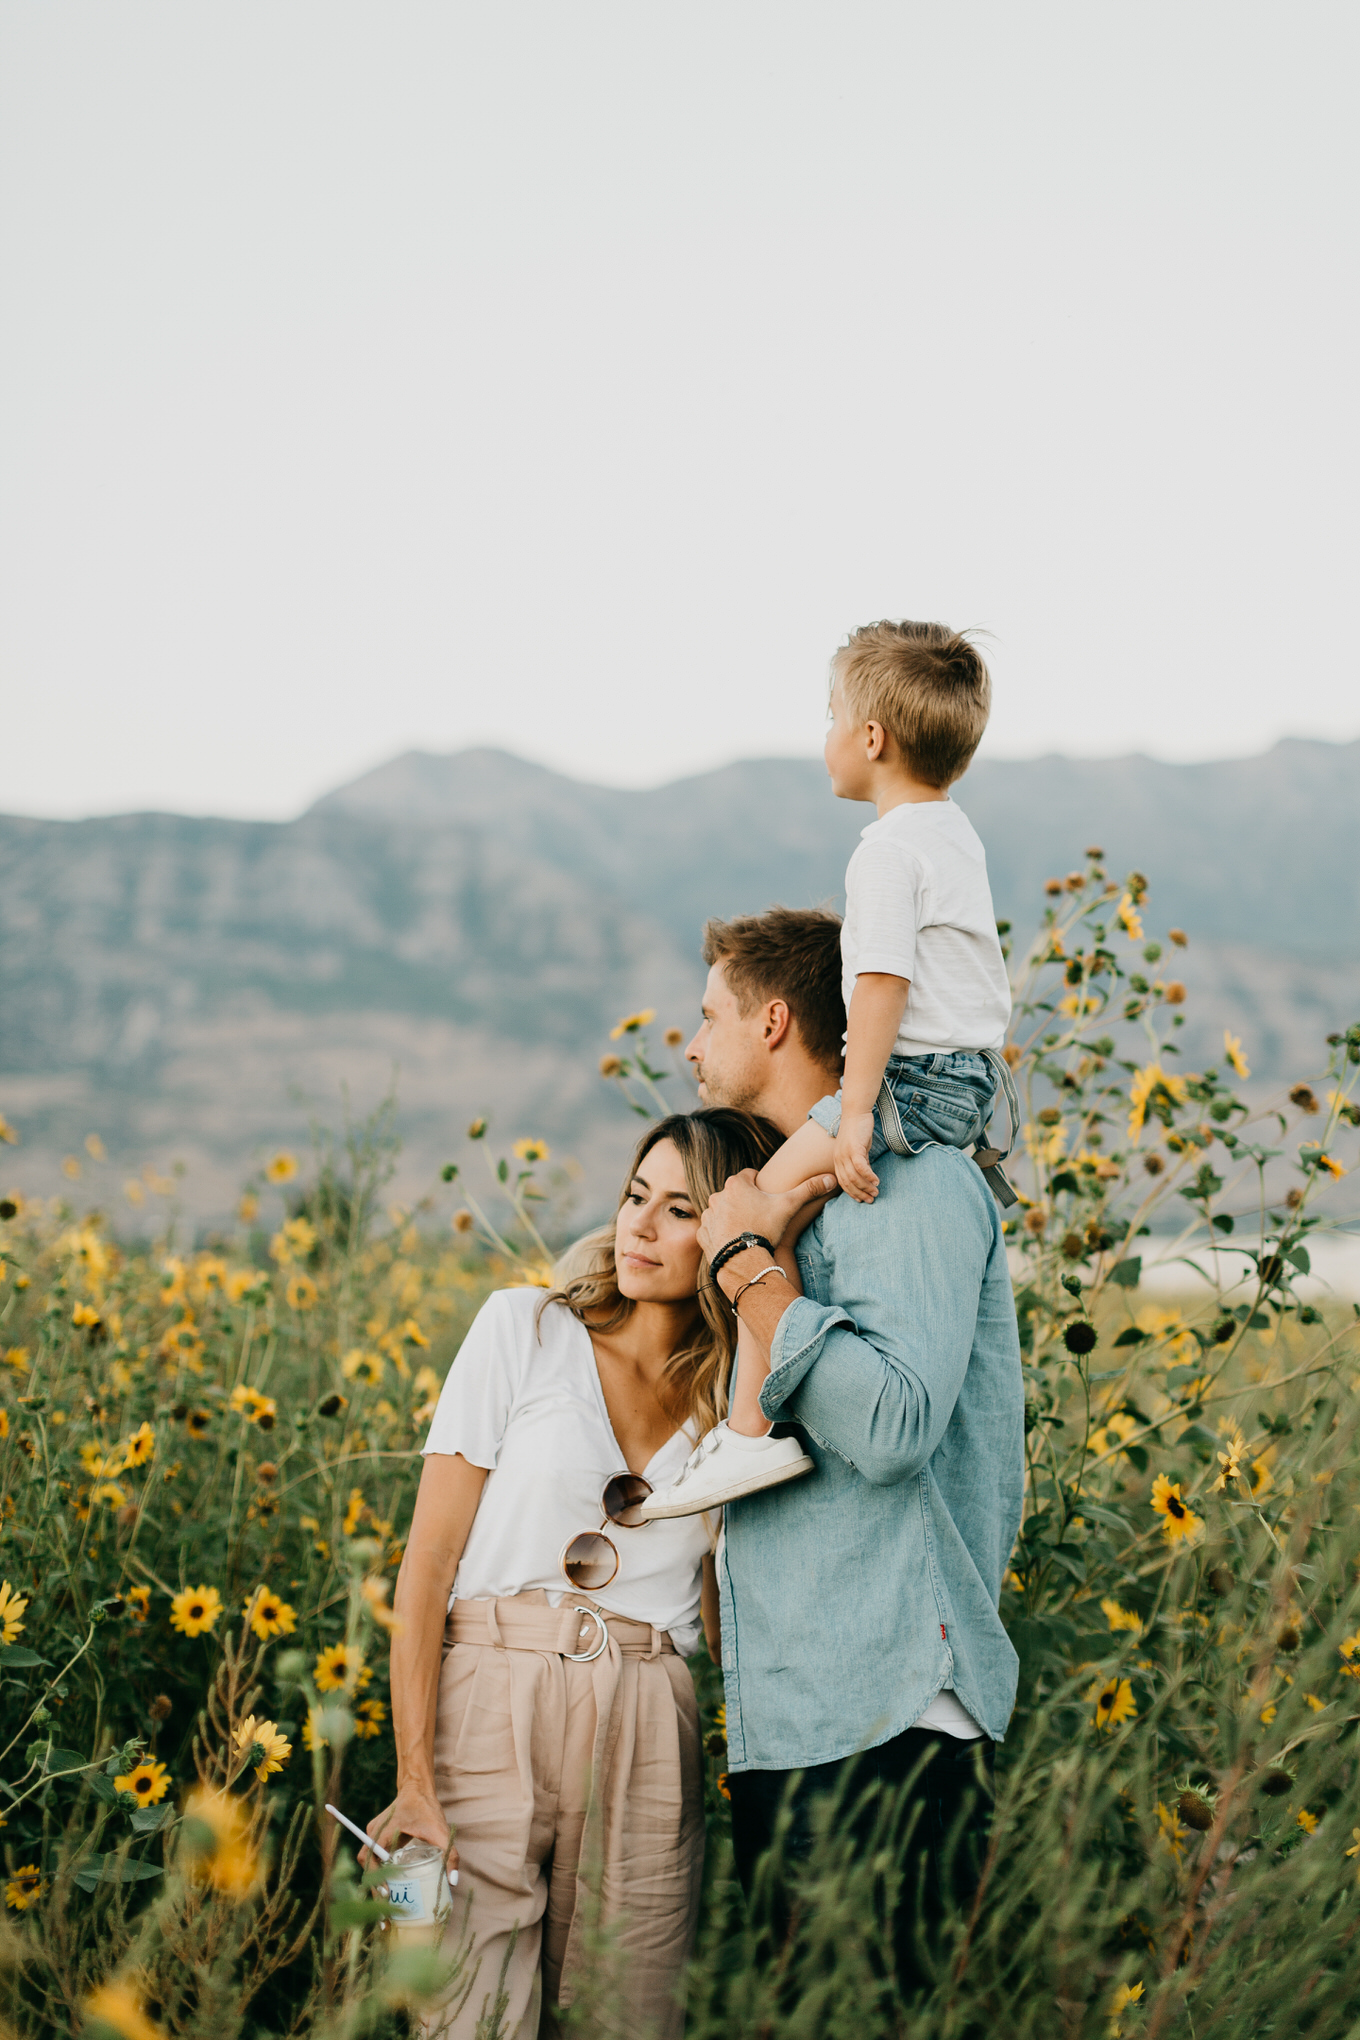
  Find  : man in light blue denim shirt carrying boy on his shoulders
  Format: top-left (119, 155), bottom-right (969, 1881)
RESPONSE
top-left (685, 908), bottom-right (1024, 1989)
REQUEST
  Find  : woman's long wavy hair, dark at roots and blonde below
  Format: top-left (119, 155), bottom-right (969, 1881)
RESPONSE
top-left (538, 1106), bottom-right (783, 1434)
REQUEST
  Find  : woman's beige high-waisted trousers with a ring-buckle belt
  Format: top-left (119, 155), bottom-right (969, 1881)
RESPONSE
top-left (424, 1589), bottom-right (703, 2040)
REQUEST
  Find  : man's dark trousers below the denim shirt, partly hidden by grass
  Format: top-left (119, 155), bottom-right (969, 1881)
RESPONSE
top-left (728, 1728), bottom-right (993, 1997)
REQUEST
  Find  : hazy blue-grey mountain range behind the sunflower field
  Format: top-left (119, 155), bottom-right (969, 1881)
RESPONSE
top-left (0, 743), bottom-right (1360, 1214)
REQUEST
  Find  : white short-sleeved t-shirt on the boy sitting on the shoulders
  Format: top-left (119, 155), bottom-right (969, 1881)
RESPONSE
top-left (840, 800), bottom-right (1011, 1055)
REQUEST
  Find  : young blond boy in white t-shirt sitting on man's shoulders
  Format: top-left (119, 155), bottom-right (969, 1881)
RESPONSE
top-left (642, 622), bottom-right (1011, 1518)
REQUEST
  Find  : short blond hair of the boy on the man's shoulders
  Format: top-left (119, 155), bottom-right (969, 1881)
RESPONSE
top-left (832, 622), bottom-right (991, 785)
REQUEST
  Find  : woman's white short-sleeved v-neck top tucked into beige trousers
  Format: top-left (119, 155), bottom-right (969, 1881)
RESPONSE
top-left (422, 1289), bottom-right (710, 1656)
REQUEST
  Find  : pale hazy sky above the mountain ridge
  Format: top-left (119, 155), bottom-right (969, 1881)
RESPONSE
top-left (0, 0), bottom-right (1360, 816)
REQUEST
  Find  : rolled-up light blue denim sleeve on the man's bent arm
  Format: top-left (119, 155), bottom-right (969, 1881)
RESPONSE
top-left (761, 1149), bottom-right (995, 1487)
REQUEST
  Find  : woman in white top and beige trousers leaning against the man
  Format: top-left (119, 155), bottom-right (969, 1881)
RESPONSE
top-left (369, 1110), bottom-right (781, 2040)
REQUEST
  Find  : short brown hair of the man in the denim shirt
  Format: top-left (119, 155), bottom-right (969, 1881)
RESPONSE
top-left (703, 906), bottom-right (846, 1069)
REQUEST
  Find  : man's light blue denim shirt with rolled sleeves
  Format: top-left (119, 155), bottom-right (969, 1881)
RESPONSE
top-left (718, 1146), bottom-right (1024, 1771)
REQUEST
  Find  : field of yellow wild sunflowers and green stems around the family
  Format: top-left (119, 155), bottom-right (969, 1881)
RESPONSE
top-left (0, 851), bottom-right (1360, 2040)
